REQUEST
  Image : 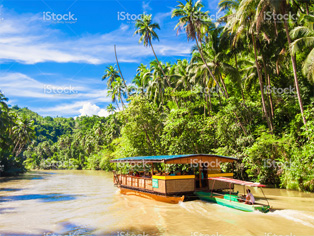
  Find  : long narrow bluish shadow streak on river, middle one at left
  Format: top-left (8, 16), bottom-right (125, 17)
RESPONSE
top-left (0, 193), bottom-right (79, 202)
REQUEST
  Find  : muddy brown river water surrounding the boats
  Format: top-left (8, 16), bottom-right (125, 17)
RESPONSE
top-left (0, 171), bottom-right (314, 236)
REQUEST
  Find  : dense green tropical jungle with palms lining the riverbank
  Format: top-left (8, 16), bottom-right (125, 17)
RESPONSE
top-left (0, 0), bottom-right (314, 191)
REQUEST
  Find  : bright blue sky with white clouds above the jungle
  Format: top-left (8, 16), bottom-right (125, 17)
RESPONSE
top-left (0, 0), bottom-right (219, 117)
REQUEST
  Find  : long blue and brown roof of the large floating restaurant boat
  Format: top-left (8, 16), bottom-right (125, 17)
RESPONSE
top-left (111, 154), bottom-right (237, 164)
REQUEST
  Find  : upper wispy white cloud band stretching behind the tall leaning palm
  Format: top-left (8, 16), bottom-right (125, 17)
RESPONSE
top-left (0, 8), bottom-right (190, 64)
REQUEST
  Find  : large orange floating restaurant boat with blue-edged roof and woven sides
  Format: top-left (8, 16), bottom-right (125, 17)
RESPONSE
top-left (111, 154), bottom-right (237, 203)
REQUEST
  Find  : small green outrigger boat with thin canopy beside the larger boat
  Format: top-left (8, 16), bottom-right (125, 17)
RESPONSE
top-left (195, 177), bottom-right (271, 213)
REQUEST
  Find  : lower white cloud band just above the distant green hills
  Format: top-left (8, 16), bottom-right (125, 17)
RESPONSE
top-left (0, 73), bottom-right (111, 116)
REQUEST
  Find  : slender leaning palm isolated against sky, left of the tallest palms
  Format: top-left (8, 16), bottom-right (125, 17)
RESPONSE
top-left (134, 14), bottom-right (168, 85)
